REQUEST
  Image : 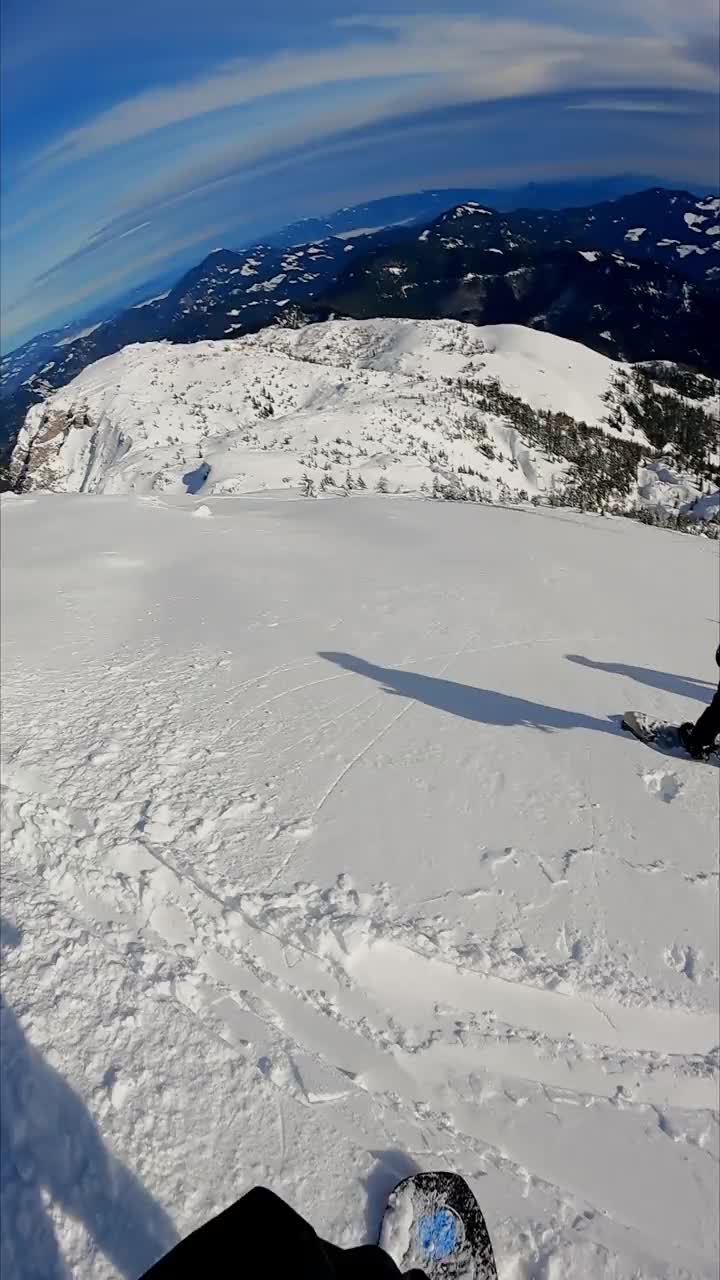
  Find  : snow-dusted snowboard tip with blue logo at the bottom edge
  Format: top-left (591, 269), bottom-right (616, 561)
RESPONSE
top-left (379, 1172), bottom-right (497, 1280)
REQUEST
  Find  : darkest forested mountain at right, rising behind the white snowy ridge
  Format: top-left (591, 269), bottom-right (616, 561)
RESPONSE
top-left (314, 192), bottom-right (720, 372)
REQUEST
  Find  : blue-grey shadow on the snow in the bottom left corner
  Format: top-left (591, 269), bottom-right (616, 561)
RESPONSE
top-left (0, 920), bottom-right (178, 1280)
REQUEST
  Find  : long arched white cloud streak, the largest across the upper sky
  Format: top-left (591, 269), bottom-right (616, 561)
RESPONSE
top-left (35, 14), bottom-right (716, 165)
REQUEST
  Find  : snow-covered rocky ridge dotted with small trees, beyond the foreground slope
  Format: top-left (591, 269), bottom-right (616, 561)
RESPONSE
top-left (13, 320), bottom-right (650, 497)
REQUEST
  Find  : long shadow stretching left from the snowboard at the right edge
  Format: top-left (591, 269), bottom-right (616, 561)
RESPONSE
top-left (318, 653), bottom-right (619, 735)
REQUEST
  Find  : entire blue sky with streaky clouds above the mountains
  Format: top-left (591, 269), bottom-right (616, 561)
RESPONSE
top-left (0, 0), bottom-right (717, 349)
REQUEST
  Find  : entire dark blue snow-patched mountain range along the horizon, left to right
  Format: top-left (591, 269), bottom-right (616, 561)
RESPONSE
top-left (0, 180), bottom-right (720, 460)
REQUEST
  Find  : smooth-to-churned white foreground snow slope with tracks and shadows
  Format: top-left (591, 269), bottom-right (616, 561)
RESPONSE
top-left (0, 491), bottom-right (719, 1280)
